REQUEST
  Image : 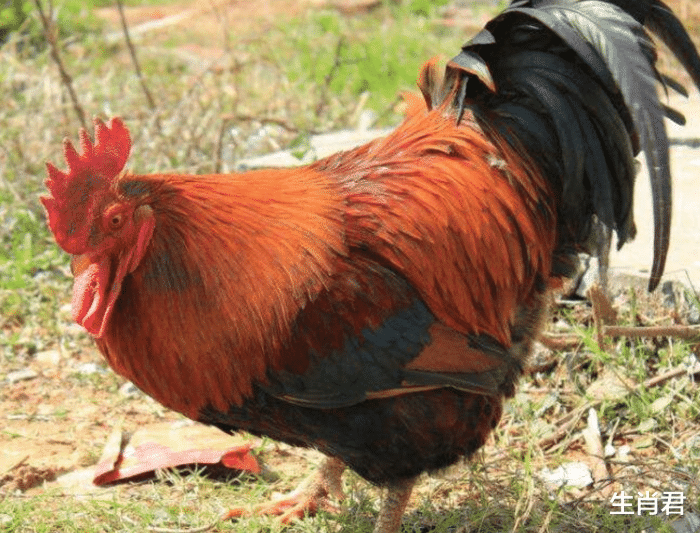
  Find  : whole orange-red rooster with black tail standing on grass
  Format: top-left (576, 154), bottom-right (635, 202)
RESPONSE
top-left (42, 0), bottom-right (700, 533)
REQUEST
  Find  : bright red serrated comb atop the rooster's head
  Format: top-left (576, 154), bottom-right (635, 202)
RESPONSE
top-left (41, 118), bottom-right (131, 254)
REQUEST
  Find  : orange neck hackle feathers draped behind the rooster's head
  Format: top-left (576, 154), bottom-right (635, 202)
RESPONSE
top-left (100, 169), bottom-right (345, 417)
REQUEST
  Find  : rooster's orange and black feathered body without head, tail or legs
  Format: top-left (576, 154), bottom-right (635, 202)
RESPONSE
top-left (83, 109), bottom-right (554, 483)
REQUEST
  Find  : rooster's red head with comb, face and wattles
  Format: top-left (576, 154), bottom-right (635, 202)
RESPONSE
top-left (41, 118), bottom-right (155, 337)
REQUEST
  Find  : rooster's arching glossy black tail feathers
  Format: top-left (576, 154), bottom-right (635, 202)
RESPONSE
top-left (445, 0), bottom-right (700, 290)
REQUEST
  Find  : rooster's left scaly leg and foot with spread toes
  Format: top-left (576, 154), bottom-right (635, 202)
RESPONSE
top-left (222, 457), bottom-right (345, 524)
